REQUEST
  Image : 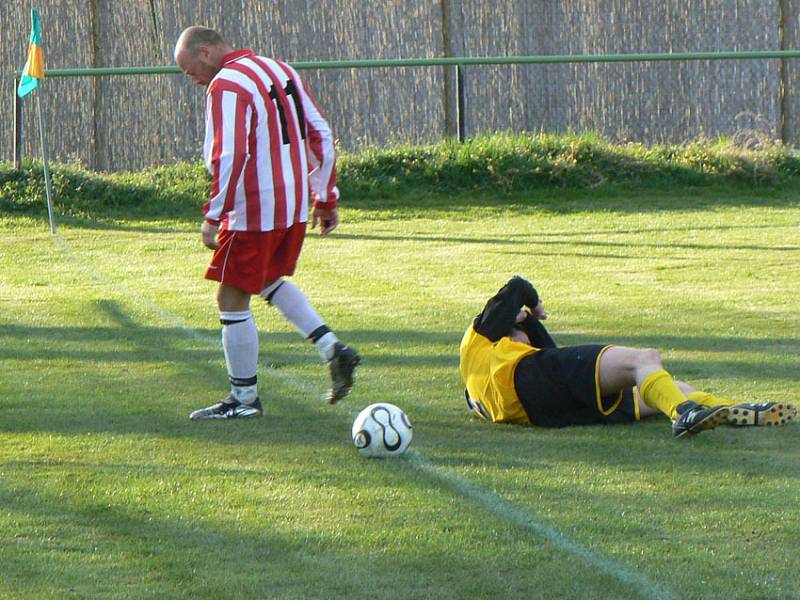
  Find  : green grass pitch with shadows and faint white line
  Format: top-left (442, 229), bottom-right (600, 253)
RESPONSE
top-left (0, 180), bottom-right (800, 599)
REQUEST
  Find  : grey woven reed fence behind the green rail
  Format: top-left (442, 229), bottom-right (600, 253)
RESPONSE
top-left (0, 0), bottom-right (800, 171)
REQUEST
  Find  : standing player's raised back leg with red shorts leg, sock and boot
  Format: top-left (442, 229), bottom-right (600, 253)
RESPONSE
top-left (259, 223), bottom-right (361, 404)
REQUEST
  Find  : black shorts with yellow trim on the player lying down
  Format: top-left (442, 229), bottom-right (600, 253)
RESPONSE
top-left (514, 344), bottom-right (639, 427)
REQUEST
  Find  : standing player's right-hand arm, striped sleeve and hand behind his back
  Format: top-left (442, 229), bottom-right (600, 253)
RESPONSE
top-left (282, 63), bottom-right (339, 235)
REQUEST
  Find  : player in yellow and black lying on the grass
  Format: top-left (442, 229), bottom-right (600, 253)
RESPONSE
top-left (460, 277), bottom-right (797, 437)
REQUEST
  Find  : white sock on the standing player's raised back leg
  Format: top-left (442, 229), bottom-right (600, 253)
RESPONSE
top-left (259, 279), bottom-right (339, 360)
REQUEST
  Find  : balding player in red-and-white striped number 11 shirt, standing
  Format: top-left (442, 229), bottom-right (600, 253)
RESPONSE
top-left (175, 26), bottom-right (360, 419)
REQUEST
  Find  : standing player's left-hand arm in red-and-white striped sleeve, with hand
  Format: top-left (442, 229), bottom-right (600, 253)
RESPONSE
top-left (201, 82), bottom-right (252, 248)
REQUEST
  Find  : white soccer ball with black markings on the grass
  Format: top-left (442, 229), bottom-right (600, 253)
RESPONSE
top-left (353, 402), bottom-right (413, 458)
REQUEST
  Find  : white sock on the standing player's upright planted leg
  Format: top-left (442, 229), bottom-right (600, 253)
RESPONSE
top-left (219, 310), bottom-right (258, 402)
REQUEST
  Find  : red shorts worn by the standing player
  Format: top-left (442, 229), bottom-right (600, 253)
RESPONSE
top-left (206, 223), bottom-right (306, 294)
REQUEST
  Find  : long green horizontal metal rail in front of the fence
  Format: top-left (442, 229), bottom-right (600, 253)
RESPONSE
top-left (19, 50), bottom-right (800, 77)
